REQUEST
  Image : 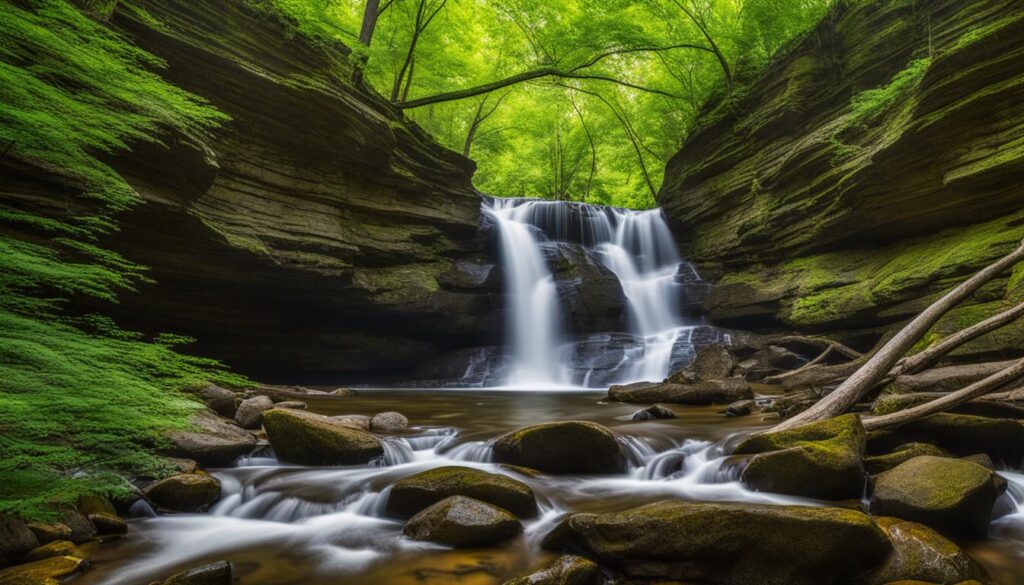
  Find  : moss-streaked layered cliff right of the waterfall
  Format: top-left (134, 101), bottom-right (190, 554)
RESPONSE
top-left (658, 0), bottom-right (1024, 354)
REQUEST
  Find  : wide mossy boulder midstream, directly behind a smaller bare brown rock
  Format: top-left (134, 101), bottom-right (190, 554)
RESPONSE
top-left (387, 465), bottom-right (537, 518)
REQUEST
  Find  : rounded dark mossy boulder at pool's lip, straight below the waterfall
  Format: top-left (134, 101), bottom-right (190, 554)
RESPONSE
top-left (494, 421), bottom-right (626, 473)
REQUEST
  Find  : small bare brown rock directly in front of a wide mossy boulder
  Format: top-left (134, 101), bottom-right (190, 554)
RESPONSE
top-left (404, 496), bottom-right (522, 548)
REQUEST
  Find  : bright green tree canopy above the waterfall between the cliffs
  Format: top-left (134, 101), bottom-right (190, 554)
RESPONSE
top-left (262, 0), bottom-right (833, 208)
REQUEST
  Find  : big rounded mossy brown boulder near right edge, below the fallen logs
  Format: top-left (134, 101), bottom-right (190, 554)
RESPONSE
top-left (870, 455), bottom-right (1007, 537)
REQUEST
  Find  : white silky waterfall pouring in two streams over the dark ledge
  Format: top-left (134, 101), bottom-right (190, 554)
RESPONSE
top-left (483, 199), bottom-right (693, 388)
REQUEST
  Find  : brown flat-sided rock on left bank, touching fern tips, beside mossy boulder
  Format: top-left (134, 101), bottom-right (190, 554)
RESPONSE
top-left (168, 410), bottom-right (256, 467)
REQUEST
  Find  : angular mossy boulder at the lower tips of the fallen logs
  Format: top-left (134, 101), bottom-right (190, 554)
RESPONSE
top-left (730, 414), bottom-right (865, 500)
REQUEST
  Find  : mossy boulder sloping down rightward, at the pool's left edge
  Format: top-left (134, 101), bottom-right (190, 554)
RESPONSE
top-left (263, 409), bottom-right (384, 465)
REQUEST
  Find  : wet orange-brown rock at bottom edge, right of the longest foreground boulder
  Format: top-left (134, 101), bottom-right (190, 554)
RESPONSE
top-left (867, 517), bottom-right (988, 585)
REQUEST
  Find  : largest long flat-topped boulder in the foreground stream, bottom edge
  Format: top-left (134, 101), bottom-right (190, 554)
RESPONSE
top-left (543, 500), bottom-right (892, 585)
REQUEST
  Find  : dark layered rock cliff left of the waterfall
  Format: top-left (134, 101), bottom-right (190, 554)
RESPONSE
top-left (2, 0), bottom-right (492, 380)
